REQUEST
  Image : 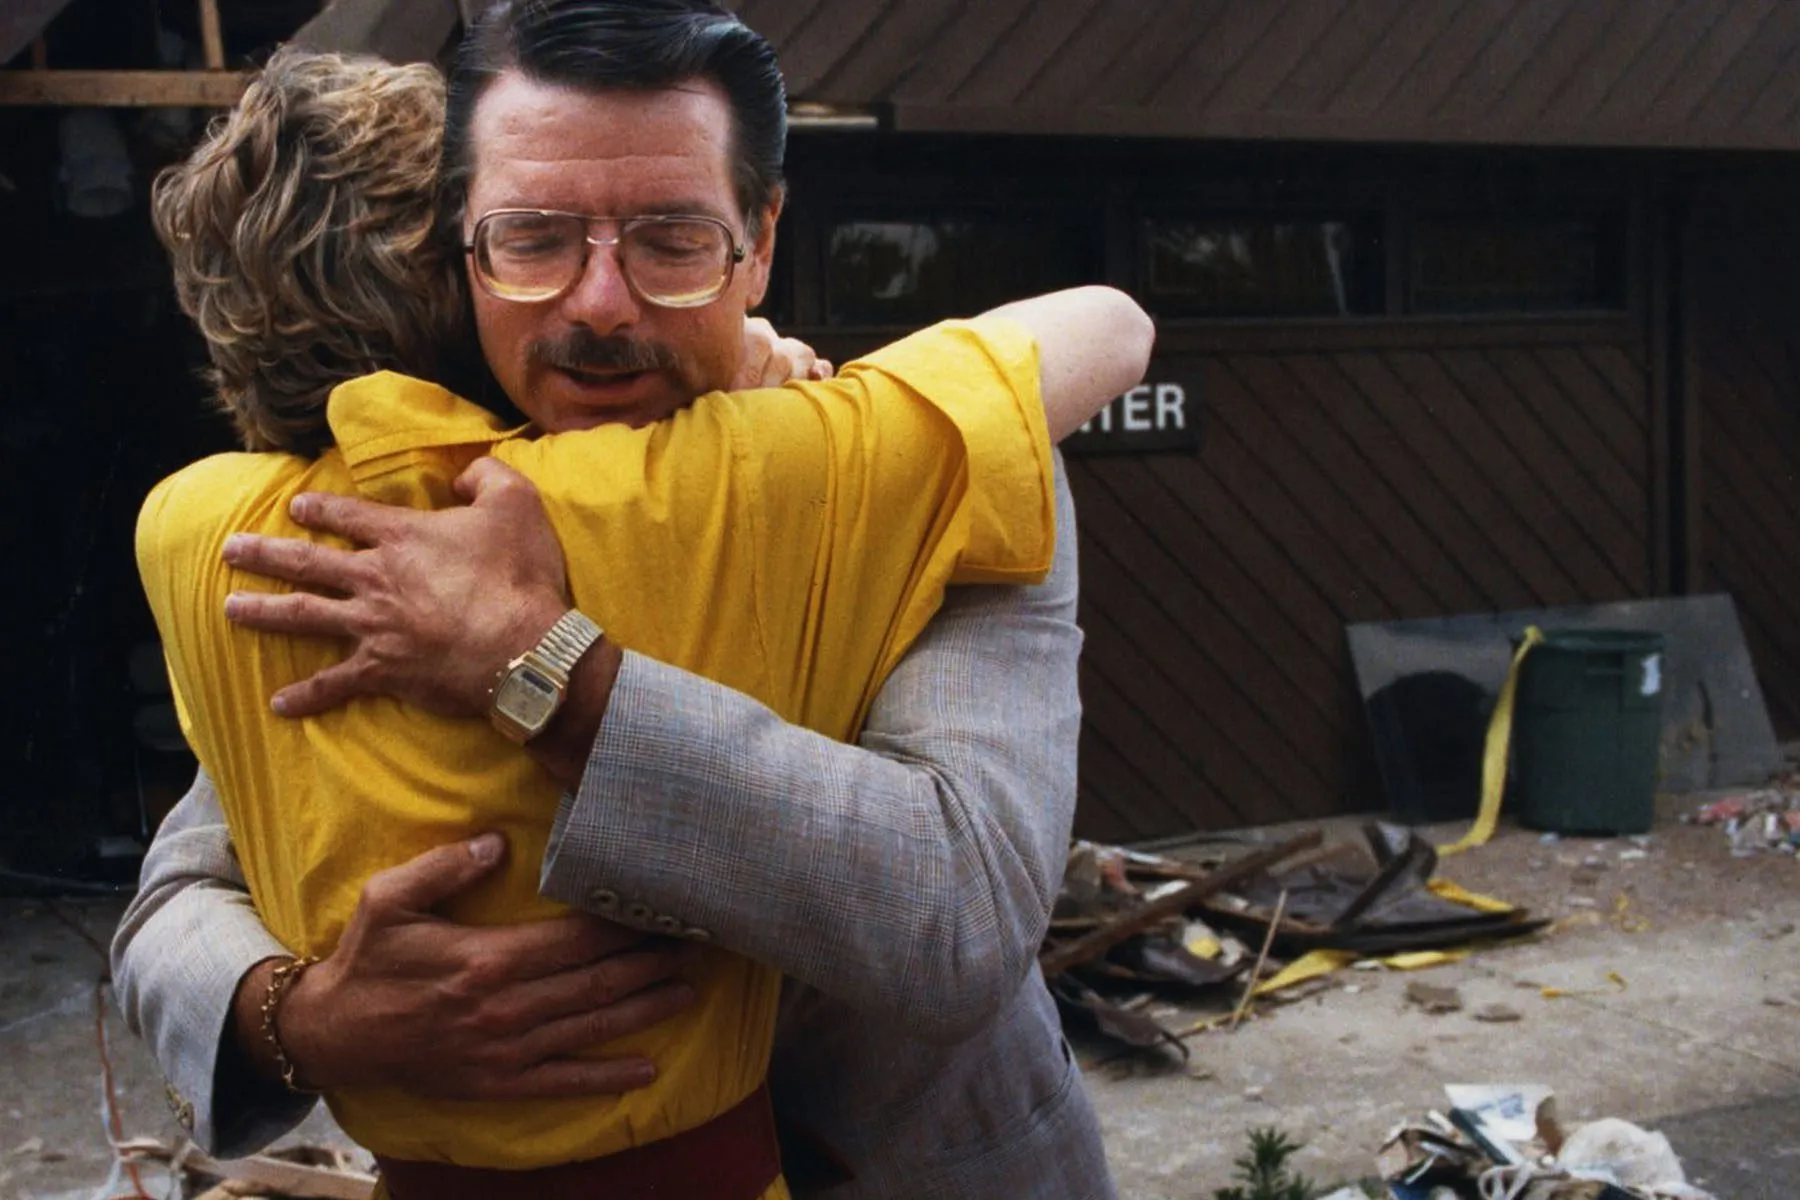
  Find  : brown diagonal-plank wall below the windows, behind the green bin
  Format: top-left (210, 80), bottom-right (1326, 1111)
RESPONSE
top-left (1069, 322), bottom-right (1656, 840)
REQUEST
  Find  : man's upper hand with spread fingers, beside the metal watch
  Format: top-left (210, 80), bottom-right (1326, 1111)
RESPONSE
top-left (225, 459), bottom-right (569, 716)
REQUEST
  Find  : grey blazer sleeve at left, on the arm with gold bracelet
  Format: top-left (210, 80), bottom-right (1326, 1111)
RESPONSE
top-left (112, 772), bottom-right (315, 1159)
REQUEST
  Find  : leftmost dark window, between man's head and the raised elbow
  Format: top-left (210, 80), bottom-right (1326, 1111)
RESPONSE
top-left (826, 214), bottom-right (1102, 326)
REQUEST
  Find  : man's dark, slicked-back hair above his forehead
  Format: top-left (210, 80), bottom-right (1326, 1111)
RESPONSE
top-left (443, 0), bottom-right (787, 237)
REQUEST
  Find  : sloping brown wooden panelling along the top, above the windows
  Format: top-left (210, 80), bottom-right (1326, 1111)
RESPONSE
top-left (738, 0), bottom-right (1800, 149)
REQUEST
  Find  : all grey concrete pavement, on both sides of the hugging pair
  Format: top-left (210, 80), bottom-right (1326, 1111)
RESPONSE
top-left (0, 791), bottom-right (1800, 1200)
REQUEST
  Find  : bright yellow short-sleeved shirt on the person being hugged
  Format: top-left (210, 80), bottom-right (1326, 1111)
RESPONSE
top-left (137, 320), bottom-right (1055, 1168)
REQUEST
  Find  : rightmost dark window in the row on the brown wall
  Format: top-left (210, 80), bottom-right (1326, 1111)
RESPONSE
top-left (1406, 216), bottom-right (1625, 313)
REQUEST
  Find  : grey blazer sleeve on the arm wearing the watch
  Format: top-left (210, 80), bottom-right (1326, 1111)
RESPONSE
top-left (542, 457), bottom-right (1082, 1042)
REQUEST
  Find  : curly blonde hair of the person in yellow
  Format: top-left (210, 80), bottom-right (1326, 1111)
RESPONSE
top-left (151, 50), bottom-right (472, 455)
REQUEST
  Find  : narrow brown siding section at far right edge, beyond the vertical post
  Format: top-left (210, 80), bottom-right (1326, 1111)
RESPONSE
top-left (1690, 185), bottom-right (1800, 738)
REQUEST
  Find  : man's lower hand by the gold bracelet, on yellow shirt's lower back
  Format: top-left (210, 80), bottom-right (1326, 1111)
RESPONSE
top-left (250, 833), bottom-right (693, 1099)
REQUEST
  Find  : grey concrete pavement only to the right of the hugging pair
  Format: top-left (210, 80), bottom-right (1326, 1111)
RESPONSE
top-left (1080, 802), bottom-right (1800, 1200)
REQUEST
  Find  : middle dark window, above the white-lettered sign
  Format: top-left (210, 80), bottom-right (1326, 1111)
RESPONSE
top-left (1139, 218), bottom-right (1381, 317)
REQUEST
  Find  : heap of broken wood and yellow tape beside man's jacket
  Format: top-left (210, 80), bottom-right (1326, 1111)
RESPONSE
top-left (1039, 822), bottom-right (1548, 1054)
